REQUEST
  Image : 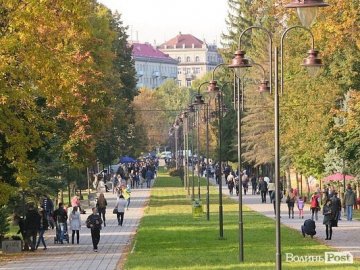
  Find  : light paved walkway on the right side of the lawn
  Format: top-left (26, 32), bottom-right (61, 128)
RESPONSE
top-left (211, 179), bottom-right (360, 258)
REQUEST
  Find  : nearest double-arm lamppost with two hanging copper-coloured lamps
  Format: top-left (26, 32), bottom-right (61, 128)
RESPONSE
top-left (229, 0), bottom-right (327, 270)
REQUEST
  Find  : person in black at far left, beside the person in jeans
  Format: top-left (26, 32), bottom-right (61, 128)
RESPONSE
top-left (25, 204), bottom-right (41, 251)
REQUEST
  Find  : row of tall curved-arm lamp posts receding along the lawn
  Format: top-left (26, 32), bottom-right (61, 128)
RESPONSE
top-left (169, 0), bottom-right (328, 270)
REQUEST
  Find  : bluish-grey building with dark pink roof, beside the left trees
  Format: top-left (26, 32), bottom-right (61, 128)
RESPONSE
top-left (131, 43), bottom-right (178, 89)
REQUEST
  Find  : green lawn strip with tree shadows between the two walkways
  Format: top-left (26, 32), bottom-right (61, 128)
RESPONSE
top-left (124, 173), bottom-right (360, 270)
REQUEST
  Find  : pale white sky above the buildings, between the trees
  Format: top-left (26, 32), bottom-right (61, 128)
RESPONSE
top-left (98, 0), bottom-right (227, 45)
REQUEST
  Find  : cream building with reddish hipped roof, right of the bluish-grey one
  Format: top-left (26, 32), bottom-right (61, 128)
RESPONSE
top-left (158, 33), bottom-right (222, 87)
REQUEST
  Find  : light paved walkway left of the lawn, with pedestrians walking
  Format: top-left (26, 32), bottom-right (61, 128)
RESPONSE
top-left (0, 189), bottom-right (150, 270)
